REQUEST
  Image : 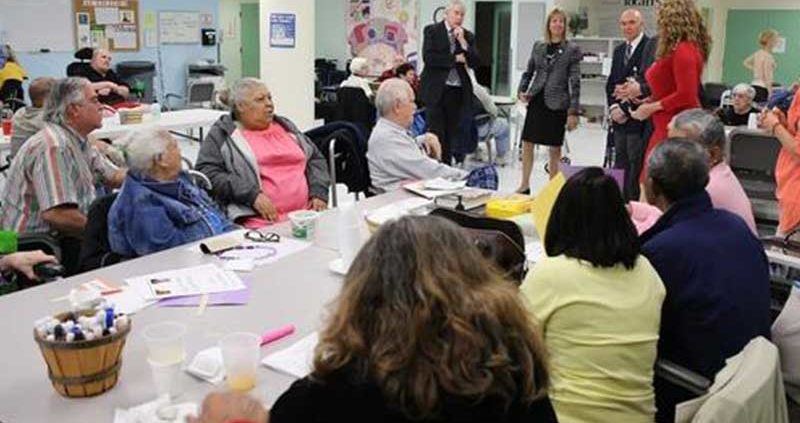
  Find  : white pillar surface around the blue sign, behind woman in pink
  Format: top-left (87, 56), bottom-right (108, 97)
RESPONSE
top-left (259, 0), bottom-right (316, 130)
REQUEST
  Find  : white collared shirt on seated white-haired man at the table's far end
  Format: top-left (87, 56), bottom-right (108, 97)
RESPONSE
top-left (367, 118), bottom-right (468, 191)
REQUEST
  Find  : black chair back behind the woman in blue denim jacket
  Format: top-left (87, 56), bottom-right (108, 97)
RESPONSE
top-left (78, 193), bottom-right (126, 272)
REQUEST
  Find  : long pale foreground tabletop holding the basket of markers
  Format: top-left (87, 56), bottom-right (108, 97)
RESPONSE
top-left (0, 192), bottom-right (411, 423)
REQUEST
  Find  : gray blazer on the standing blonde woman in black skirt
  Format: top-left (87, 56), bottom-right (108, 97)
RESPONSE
top-left (518, 41), bottom-right (583, 114)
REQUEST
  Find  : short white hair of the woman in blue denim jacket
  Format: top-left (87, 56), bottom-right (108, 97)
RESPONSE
top-left (115, 127), bottom-right (176, 175)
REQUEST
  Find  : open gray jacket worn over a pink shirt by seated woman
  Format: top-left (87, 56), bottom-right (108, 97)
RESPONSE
top-left (195, 115), bottom-right (330, 221)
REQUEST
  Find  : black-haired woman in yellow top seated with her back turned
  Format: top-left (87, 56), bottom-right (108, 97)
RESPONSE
top-left (521, 168), bottom-right (665, 423)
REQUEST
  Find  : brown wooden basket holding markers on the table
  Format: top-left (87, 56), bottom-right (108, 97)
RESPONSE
top-left (33, 313), bottom-right (131, 398)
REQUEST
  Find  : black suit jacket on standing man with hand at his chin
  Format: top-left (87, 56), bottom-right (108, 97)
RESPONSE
top-left (420, 21), bottom-right (480, 106)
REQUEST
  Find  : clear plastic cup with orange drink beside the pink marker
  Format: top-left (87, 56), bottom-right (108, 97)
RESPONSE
top-left (219, 332), bottom-right (261, 392)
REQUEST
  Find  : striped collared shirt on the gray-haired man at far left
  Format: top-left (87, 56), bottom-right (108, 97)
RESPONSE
top-left (0, 123), bottom-right (117, 233)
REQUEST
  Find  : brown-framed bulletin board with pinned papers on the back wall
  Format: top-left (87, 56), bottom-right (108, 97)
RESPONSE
top-left (73, 0), bottom-right (139, 51)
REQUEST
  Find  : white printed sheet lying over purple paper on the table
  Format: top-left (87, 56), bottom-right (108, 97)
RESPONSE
top-left (126, 264), bottom-right (245, 299)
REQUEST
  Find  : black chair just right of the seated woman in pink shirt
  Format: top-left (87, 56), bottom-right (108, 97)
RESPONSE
top-left (306, 122), bottom-right (372, 207)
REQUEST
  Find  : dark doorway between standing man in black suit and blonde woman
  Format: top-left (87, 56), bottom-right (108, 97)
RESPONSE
top-left (475, 1), bottom-right (511, 96)
